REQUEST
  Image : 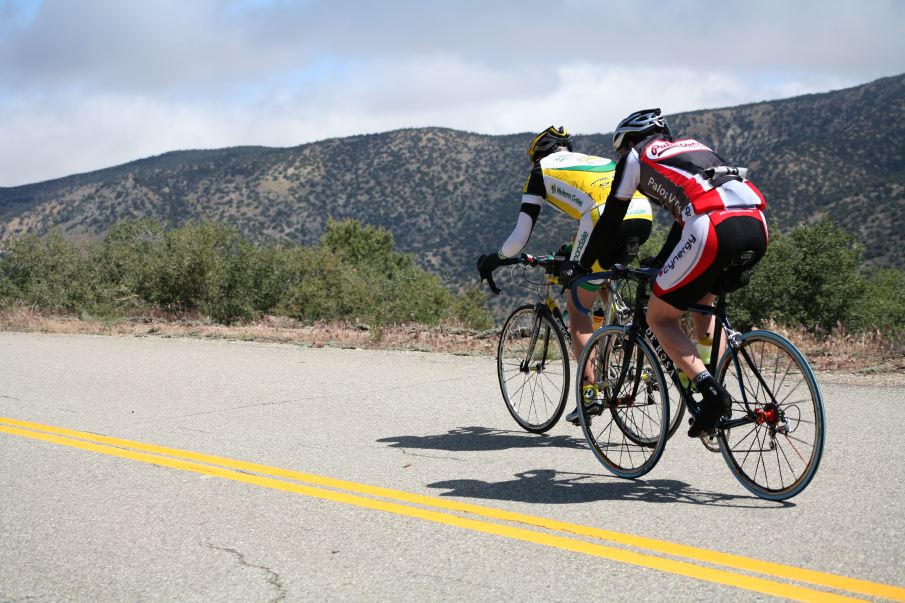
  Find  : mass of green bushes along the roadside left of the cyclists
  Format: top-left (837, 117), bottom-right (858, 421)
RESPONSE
top-left (0, 220), bottom-right (492, 329)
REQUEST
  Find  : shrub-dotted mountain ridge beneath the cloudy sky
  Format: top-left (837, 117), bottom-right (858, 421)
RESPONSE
top-left (0, 75), bottom-right (905, 285)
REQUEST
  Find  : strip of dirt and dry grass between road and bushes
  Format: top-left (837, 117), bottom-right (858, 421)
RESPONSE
top-left (0, 309), bottom-right (905, 387)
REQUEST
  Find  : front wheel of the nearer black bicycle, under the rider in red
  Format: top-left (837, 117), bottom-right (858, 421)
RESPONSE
top-left (576, 326), bottom-right (669, 478)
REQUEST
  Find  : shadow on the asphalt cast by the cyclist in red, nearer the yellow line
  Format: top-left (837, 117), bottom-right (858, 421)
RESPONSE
top-left (427, 469), bottom-right (795, 509)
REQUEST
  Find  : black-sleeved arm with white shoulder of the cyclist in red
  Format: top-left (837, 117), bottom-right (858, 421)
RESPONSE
top-left (578, 149), bottom-right (641, 269)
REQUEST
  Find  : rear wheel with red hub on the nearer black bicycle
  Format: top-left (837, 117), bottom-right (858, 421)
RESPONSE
top-left (717, 331), bottom-right (824, 500)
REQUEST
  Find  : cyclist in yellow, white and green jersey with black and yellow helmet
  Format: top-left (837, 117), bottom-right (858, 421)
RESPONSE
top-left (477, 126), bottom-right (653, 419)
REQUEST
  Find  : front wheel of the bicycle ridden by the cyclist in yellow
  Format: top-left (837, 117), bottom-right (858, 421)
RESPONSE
top-left (497, 305), bottom-right (569, 433)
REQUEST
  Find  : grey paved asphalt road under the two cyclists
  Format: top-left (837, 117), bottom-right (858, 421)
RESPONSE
top-left (0, 333), bottom-right (905, 601)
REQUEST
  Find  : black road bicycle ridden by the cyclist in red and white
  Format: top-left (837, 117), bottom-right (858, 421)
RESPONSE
top-left (573, 257), bottom-right (824, 500)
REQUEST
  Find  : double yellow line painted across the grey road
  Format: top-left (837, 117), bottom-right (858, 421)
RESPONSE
top-left (0, 417), bottom-right (905, 602)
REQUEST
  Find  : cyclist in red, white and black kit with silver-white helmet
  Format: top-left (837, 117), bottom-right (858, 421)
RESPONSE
top-left (562, 109), bottom-right (768, 437)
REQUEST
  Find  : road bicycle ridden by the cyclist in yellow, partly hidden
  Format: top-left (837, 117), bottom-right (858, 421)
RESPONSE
top-left (488, 254), bottom-right (681, 433)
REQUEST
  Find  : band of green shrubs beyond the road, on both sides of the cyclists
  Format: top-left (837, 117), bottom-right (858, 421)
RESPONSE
top-left (0, 220), bottom-right (905, 338)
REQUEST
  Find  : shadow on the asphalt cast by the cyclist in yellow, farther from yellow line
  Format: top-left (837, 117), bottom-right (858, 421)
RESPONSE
top-left (377, 427), bottom-right (587, 452)
